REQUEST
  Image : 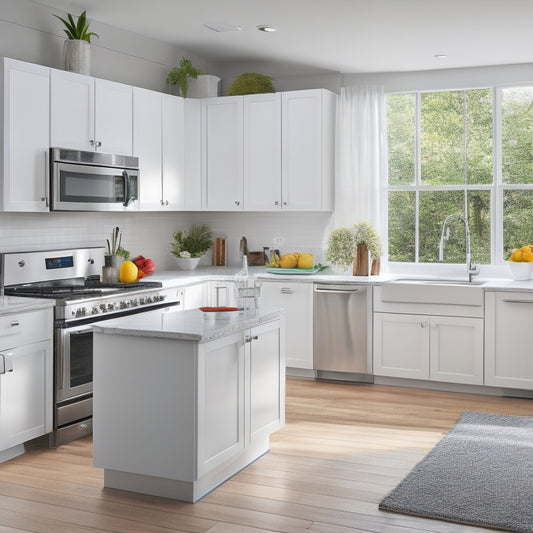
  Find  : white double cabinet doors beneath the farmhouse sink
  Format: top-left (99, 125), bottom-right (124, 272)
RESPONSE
top-left (374, 313), bottom-right (483, 385)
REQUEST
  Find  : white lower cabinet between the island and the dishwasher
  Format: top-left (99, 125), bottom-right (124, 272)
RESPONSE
top-left (261, 280), bottom-right (313, 369)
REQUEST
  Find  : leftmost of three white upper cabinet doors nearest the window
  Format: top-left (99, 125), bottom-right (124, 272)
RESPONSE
top-left (202, 96), bottom-right (243, 211)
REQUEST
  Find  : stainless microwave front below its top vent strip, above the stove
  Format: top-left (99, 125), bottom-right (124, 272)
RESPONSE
top-left (51, 162), bottom-right (139, 211)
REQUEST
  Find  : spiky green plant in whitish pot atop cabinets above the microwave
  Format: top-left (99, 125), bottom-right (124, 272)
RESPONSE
top-left (54, 11), bottom-right (99, 75)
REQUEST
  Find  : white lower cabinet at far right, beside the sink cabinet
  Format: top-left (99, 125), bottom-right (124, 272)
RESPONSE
top-left (485, 292), bottom-right (533, 389)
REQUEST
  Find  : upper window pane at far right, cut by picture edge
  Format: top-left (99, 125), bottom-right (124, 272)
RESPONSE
top-left (502, 87), bottom-right (533, 183)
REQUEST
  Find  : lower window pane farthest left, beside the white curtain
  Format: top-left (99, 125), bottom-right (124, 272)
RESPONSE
top-left (389, 192), bottom-right (415, 263)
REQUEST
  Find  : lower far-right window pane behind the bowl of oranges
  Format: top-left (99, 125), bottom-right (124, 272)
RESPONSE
top-left (503, 190), bottom-right (533, 259)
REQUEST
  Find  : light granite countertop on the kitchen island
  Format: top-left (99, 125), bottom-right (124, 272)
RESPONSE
top-left (94, 307), bottom-right (284, 342)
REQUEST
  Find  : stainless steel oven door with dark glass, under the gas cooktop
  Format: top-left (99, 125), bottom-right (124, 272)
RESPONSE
top-left (55, 324), bottom-right (93, 403)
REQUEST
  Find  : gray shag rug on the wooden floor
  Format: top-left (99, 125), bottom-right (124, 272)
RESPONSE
top-left (379, 411), bottom-right (533, 533)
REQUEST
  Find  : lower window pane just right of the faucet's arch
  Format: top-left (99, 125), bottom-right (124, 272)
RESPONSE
top-left (467, 191), bottom-right (491, 265)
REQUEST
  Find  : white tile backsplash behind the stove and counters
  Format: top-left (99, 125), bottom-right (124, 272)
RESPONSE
top-left (0, 212), bottom-right (331, 270)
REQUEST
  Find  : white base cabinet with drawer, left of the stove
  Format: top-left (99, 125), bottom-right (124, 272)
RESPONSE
top-left (0, 309), bottom-right (53, 460)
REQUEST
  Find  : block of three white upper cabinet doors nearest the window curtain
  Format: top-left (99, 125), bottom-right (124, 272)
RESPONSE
top-left (202, 89), bottom-right (336, 211)
